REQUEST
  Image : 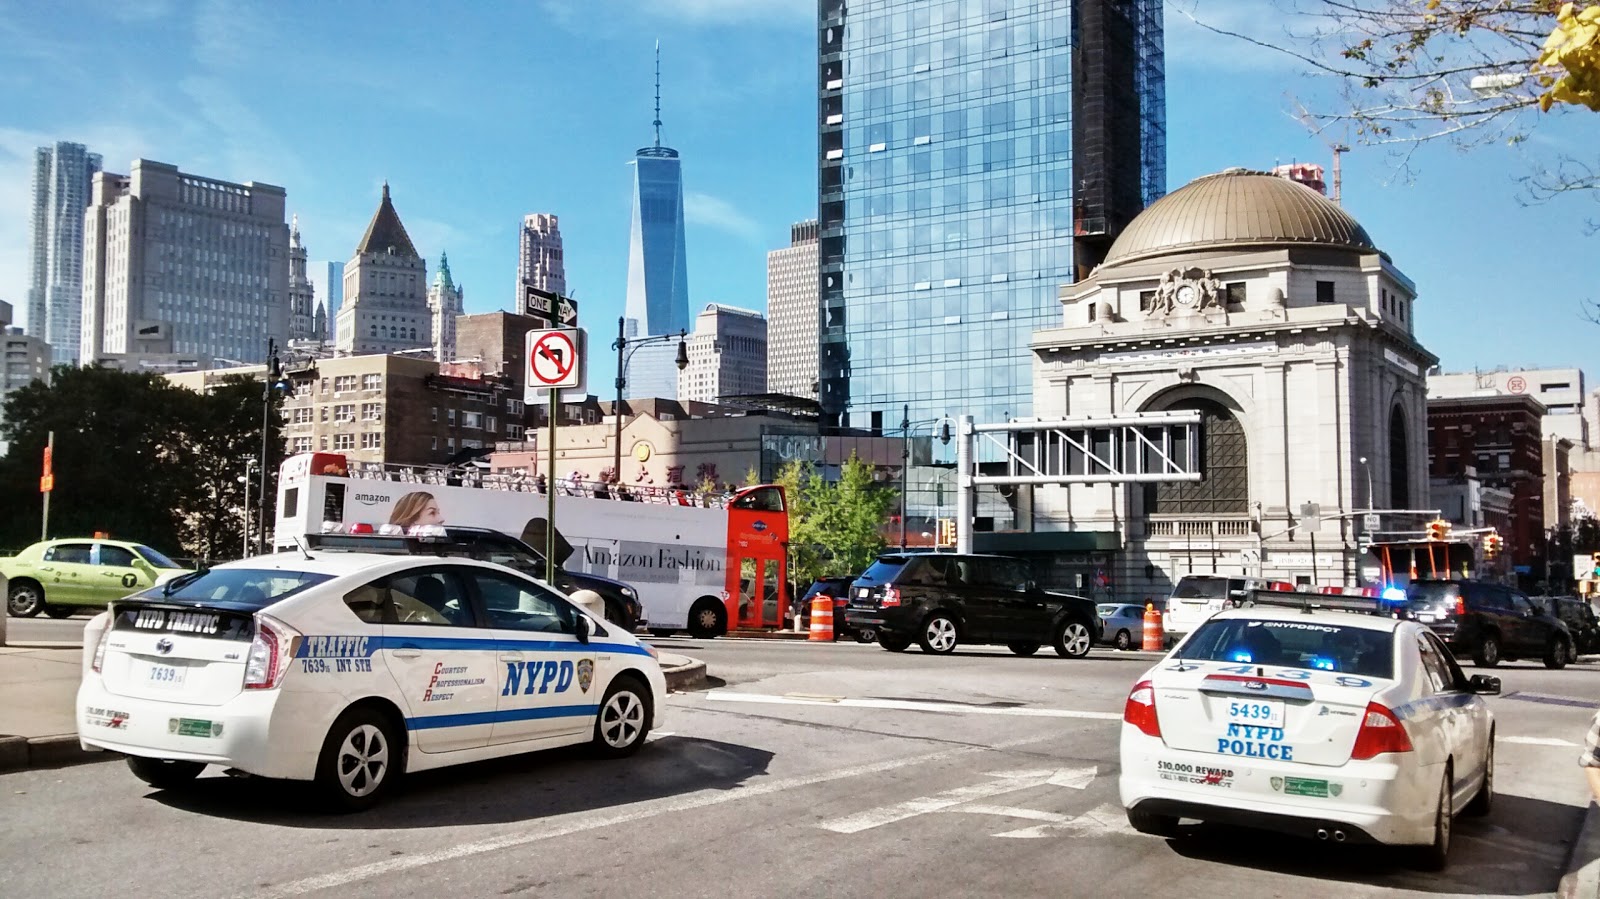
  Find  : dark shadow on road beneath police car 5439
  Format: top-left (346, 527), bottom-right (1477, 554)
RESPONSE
top-left (1168, 793), bottom-right (1584, 896)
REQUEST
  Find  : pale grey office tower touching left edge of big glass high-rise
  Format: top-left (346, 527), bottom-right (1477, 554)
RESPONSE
top-left (766, 219), bottom-right (822, 398)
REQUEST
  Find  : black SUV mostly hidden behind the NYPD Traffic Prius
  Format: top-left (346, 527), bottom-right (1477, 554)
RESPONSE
top-left (306, 525), bottom-right (648, 632)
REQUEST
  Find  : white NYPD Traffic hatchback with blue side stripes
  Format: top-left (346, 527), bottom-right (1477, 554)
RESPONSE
top-left (77, 552), bottom-right (666, 809)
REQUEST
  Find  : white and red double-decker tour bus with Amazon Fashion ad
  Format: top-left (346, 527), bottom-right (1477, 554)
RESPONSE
top-left (272, 453), bottom-right (789, 638)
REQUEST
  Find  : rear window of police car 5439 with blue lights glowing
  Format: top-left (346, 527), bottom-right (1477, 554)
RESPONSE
top-left (1178, 617), bottom-right (1394, 678)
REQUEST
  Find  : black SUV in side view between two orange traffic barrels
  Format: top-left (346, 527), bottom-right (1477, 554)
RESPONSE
top-left (845, 552), bottom-right (1102, 659)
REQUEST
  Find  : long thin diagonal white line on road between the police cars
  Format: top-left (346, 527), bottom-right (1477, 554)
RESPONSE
top-left (240, 737), bottom-right (1051, 899)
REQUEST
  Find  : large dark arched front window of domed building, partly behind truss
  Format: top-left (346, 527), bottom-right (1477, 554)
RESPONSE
top-left (1144, 398), bottom-right (1250, 515)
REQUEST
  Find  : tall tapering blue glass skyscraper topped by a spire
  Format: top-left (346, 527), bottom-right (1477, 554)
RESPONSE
top-left (624, 42), bottom-right (690, 400)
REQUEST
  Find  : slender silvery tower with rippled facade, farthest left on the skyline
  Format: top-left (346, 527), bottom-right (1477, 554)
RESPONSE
top-left (27, 141), bottom-right (101, 365)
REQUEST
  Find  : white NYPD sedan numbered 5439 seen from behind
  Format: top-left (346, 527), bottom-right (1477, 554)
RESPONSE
top-left (1120, 592), bottom-right (1499, 869)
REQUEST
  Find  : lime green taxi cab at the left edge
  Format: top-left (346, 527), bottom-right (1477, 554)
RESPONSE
top-left (0, 539), bottom-right (186, 617)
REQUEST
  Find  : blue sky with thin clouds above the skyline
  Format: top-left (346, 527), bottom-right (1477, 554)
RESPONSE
top-left (0, 0), bottom-right (1600, 384)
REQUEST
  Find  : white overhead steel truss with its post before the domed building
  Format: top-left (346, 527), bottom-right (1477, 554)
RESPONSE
top-left (955, 410), bottom-right (1202, 552)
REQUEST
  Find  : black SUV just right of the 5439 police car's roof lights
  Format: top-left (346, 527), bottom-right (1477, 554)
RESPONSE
top-left (1406, 581), bottom-right (1576, 669)
